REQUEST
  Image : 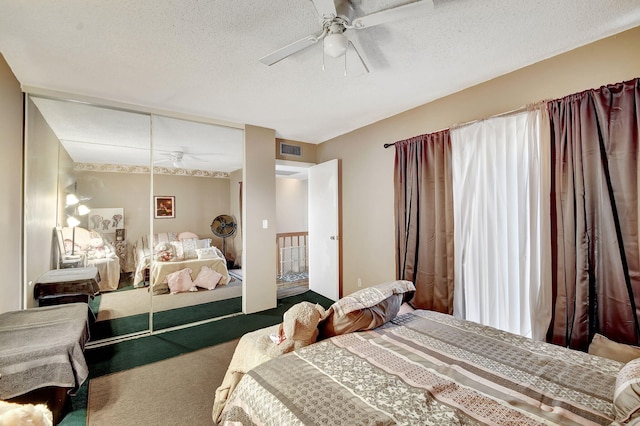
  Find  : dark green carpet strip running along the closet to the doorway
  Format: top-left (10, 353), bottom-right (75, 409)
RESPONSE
top-left (60, 290), bottom-right (333, 426)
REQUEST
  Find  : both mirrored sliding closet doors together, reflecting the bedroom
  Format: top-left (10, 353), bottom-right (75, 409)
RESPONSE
top-left (24, 95), bottom-right (244, 342)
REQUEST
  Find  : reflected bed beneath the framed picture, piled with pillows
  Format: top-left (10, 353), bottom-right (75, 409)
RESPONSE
top-left (133, 231), bottom-right (229, 294)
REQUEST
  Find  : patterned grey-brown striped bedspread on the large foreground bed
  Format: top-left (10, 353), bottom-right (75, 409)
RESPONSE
top-left (222, 311), bottom-right (623, 425)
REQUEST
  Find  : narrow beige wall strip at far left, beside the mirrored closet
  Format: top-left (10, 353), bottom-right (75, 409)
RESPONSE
top-left (0, 54), bottom-right (23, 313)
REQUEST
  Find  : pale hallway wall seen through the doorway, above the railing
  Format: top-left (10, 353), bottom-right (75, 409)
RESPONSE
top-left (276, 178), bottom-right (309, 233)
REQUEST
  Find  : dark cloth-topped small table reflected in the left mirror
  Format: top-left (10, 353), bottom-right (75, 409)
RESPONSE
top-left (33, 266), bottom-right (100, 306)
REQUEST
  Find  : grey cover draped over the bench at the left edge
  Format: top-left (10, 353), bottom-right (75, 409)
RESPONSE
top-left (0, 303), bottom-right (89, 399)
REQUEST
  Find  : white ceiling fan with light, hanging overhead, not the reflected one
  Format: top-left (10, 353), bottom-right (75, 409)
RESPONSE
top-left (260, 0), bottom-right (433, 72)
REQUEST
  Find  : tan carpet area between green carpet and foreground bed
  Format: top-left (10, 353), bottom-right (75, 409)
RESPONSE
top-left (87, 339), bottom-right (238, 426)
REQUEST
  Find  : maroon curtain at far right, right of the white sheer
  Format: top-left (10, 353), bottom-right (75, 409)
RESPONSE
top-left (548, 79), bottom-right (640, 350)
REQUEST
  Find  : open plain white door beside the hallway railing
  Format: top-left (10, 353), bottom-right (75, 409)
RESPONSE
top-left (308, 160), bottom-right (340, 300)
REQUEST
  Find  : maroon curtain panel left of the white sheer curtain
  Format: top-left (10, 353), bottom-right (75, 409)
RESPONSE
top-left (394, 130), bottom-right (454, 314)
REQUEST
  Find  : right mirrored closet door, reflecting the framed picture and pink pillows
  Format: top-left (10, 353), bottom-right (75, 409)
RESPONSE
top-left (150, 115), bottom-right (244, 330)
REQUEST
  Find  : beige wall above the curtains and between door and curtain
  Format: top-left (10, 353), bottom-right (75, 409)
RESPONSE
top-left (317, 27), bottom-right (640, 295)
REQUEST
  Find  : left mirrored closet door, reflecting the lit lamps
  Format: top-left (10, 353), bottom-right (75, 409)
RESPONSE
top-left (25, 95), bottom-right (156, 341)
